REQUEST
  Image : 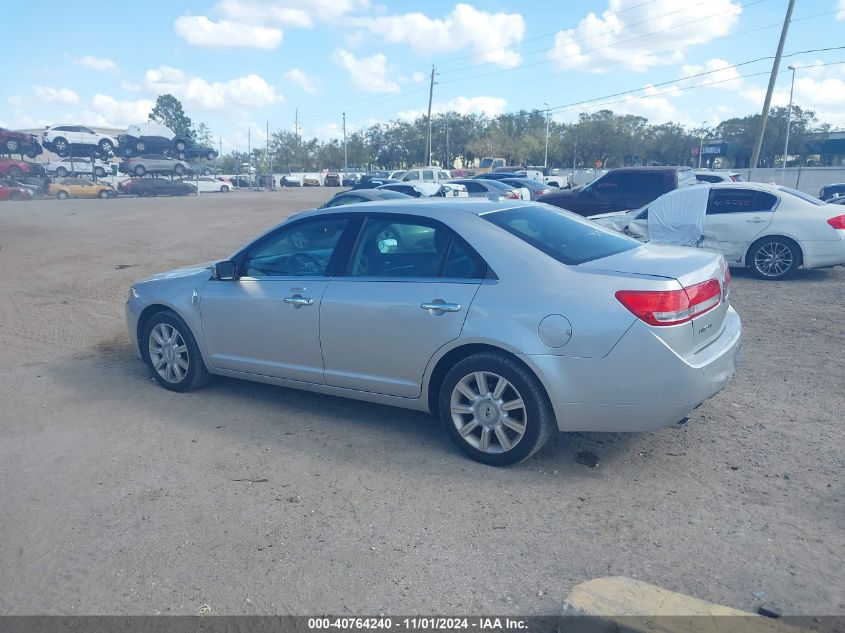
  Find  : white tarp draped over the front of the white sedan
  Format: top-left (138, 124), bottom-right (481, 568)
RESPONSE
top-left (648, 185), bottom-right (710, 246)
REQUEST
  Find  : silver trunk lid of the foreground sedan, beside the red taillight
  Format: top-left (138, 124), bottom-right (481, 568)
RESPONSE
top-left (579, 244), bottom-right (730, 357)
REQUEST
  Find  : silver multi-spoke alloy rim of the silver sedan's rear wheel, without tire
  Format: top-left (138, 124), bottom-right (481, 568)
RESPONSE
top-left (449, 371), bottom-right (528, 453)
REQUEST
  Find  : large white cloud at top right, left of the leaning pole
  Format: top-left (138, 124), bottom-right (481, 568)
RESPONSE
top-left (548, 0), bottom-right (742, 72)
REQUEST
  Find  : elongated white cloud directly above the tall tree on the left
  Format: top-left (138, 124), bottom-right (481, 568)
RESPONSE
top-left (144, 66), bottom-right (284, 110)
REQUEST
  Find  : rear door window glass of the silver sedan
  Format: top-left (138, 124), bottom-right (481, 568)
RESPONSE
top-left (349, 218), bottom-right (486, 279)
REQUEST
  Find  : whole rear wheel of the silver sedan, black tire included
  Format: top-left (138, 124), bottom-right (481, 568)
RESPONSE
top-left (437, 352), bottom-right (556, 466)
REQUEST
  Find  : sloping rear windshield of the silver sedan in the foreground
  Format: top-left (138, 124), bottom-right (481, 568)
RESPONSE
top-left (481, 207), bottom-right (642, 265)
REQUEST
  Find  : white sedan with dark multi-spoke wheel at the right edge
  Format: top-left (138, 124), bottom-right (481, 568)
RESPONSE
top-left (590, 182), bottom-right (845, 279)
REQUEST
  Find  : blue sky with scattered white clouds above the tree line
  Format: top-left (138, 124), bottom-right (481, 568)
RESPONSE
top-left (0, 0), bottom-right (845, 152)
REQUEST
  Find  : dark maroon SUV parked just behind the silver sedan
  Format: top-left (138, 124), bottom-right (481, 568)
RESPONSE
top-left (537, 167), bottom-right (697, 217)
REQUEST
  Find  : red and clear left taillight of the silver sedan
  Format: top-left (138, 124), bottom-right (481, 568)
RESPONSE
top-left (616, 278), bottom-right (727, 325)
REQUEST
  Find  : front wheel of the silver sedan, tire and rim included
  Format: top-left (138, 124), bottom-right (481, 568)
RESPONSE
top-left (141, 310), bottom-right (211, 392)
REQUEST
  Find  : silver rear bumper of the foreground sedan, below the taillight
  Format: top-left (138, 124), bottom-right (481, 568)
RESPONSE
top-left (522, 308), bottom-right (742, 432)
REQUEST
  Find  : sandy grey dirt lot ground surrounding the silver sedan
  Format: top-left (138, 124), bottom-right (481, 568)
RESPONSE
top-left (0, 190), bottom-right (845, 615)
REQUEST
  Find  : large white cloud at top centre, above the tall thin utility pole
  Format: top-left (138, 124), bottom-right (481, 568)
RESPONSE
top-left (348, 3), bottom-right (525, 68)
